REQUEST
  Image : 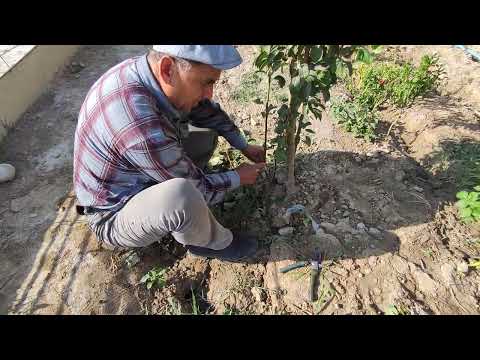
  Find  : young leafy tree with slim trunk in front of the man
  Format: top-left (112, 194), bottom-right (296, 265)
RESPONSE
top-left (254, 45), bottom-right (378, 194)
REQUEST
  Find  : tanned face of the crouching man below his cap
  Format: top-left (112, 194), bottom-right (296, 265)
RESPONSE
top-left (172, 60), bottom-right (221, 113)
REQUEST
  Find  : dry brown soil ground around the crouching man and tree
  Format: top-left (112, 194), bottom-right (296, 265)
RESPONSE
top-left (0, 46), bottom-right (480, 314)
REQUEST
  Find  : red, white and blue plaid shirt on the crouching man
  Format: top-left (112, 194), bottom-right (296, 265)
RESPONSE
top-left (73, 55), bottom-right (251, 211)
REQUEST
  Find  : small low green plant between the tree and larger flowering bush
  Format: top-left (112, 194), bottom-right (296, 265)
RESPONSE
top-left (331, 99), bottom-right (378, 141)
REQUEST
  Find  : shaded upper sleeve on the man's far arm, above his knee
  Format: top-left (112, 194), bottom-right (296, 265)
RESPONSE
top-left (189, 100), bottom-right (248, 150)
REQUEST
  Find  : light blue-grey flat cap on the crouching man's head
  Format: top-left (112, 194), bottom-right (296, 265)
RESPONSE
top-left (153, 45), bottom-right (242, 70)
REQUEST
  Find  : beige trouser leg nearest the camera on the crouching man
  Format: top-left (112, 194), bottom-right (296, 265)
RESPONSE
top-left (88, 178), bottom-right (233, 250)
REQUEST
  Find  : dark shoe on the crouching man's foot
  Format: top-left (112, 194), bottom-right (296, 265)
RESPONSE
top-left (186, 233), bottom-right (257, 262)
